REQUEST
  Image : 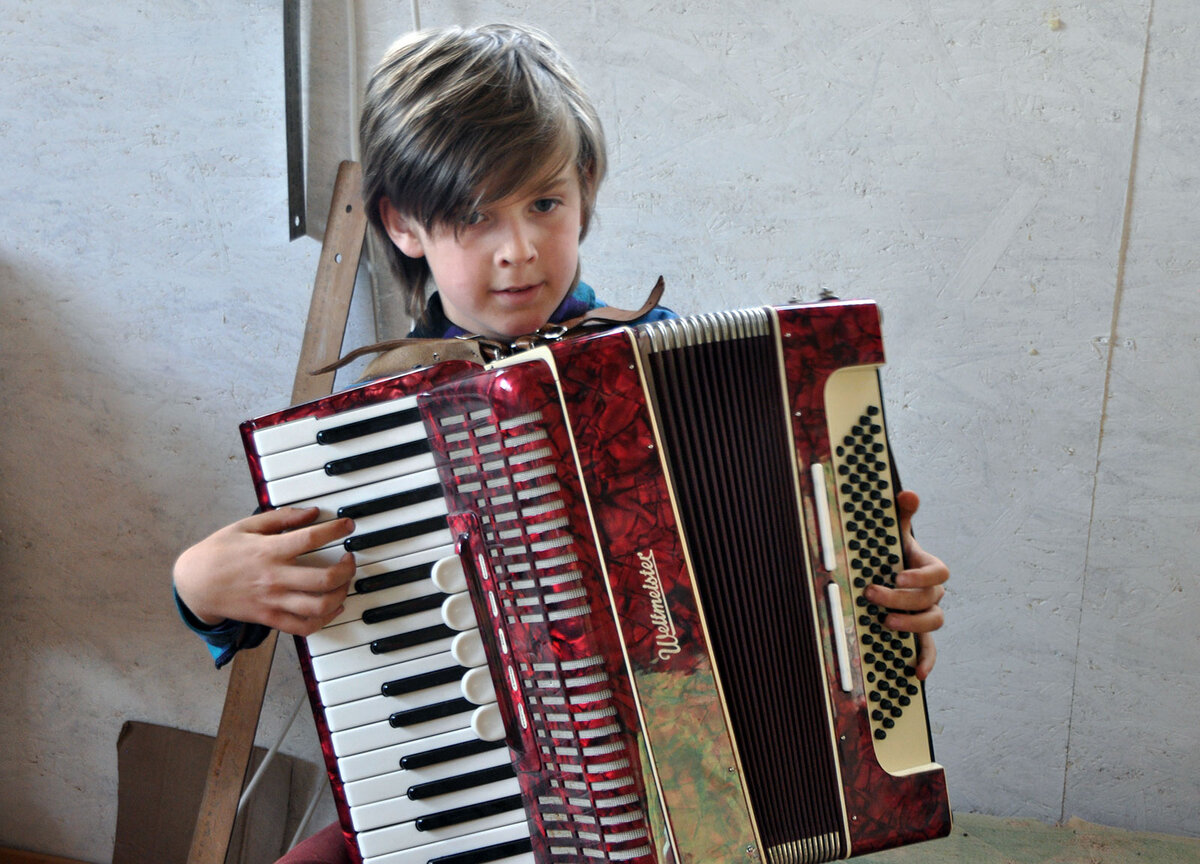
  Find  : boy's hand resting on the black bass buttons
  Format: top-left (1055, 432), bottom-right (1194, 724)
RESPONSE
top-left (865, 491), bottom-right (950, 680)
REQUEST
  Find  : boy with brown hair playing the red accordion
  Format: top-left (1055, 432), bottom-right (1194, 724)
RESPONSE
top-left (174, 25), bottom-right (949, 864)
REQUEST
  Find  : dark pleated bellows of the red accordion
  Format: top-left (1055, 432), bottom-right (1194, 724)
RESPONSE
top-left (642, 316), bottom-right (845, 864)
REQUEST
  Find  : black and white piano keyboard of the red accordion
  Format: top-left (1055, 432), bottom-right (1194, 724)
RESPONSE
top-left (246, 398), bottom-right (532, 864)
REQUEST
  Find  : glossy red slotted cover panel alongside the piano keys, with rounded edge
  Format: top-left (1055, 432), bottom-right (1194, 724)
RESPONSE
top-left (422, 362), bottom-right (662, 864)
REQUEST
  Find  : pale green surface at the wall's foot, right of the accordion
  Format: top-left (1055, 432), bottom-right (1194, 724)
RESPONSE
top-left (856, 812), bottom-right (1200, 864)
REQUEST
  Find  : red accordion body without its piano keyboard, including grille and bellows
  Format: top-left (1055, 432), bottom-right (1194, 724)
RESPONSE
top-left (418, 301), bottom-right (950, 864)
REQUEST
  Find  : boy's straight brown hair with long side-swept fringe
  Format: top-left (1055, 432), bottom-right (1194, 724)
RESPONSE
top-left (361, 24), bottom-right (607, 320)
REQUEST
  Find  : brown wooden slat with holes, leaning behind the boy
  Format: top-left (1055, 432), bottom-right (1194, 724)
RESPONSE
top-left (187, 162), bottom-right (366, 864)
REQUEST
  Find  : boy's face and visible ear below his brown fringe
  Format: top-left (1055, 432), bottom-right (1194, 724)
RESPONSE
top-left (379, 166), bottom-right (583, 340)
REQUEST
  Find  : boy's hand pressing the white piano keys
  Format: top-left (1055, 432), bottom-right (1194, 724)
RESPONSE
top-left (174, 508), bottom-right (354, 636)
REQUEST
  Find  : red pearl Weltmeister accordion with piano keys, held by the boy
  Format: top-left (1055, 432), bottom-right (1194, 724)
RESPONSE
top-left (242, 301), bottom-right (950, 864)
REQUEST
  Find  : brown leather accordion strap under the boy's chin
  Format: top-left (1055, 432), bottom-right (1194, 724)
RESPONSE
top-left (310, 276), bottom-right (666, 378)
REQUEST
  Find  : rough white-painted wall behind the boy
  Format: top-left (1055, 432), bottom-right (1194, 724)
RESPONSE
top-left (0, 0), bottom-right (1200, 862)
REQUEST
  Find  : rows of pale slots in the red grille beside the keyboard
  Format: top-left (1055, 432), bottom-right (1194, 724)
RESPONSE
top-left (438, 408), bottom-right (654, 864)
